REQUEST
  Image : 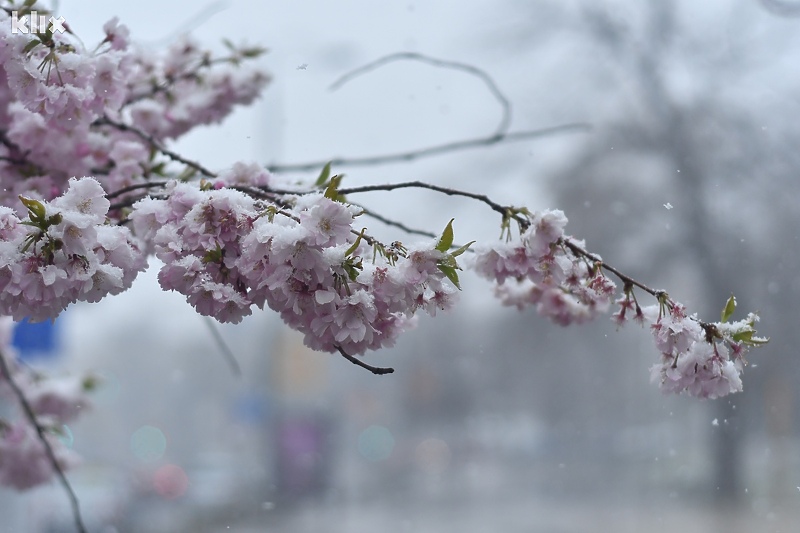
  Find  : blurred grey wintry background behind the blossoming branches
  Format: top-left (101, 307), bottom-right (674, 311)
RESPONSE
top-left (0, 0), bottom-right (800, 533)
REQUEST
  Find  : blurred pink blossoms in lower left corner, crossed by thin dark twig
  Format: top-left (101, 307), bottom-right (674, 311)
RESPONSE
top-left (0, 317), bottom-right (96, 490)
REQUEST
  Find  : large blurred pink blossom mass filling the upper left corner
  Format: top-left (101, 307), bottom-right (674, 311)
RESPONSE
top-left (0, 2), bottom-right (269, 211)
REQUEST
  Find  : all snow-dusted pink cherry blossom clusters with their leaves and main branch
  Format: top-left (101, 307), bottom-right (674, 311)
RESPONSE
top-left (0, 0), bottom-right (766, 508)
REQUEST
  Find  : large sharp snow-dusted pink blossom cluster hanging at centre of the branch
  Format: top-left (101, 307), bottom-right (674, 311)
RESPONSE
top-left (131, 177), bottom-right (455, 355)
